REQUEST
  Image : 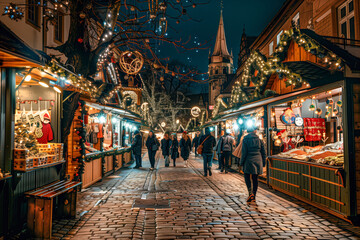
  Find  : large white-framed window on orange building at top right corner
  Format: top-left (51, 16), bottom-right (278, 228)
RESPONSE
top-left (338, 0), bottom-right (355, 39)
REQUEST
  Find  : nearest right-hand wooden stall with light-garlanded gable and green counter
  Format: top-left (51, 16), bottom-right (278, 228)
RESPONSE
top-left (208, 29), bottom-right (360, 224)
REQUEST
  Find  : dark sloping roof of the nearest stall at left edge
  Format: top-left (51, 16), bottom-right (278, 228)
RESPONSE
top-left (0, 21), bottom-right (43, 67)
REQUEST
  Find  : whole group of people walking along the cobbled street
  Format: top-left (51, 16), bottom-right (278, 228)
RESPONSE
top-left (131, 127), bottom-right (266, 202)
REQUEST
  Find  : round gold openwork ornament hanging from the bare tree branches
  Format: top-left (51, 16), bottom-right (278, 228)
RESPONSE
top-left (119, 51), bottom-right (144, 75)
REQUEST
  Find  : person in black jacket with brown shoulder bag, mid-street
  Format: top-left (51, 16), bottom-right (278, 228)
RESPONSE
top-left (199, 127), bottom-right (216, 177)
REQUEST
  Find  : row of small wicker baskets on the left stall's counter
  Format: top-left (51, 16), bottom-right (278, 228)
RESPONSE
top-left (14, 143), bottom-right (65, 172)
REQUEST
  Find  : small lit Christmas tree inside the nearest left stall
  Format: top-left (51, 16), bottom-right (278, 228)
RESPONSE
top-left (15, 121), bottom-right (39, 155)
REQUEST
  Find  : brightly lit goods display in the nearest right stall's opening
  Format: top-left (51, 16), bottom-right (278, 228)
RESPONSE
top-left (270, 88), bottom-right (344, 166)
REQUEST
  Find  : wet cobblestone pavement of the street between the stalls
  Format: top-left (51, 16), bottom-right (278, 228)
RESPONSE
top-left (53, 153), bottom-right (360, 239)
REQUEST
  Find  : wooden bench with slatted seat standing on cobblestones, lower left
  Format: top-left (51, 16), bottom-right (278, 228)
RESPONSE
top-left (25, 180), bottom-right (81, 239)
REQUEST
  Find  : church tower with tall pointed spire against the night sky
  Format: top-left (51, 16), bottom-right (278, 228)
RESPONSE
top-left (209, 10), bottom-right (234, 106)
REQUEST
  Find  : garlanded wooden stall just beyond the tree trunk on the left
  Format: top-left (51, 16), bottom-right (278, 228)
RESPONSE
top-left (67, 100), bottom-right (141, 188)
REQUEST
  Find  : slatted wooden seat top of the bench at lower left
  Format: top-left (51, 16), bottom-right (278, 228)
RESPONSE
top-left (25, 180), bottom-right (81, 198)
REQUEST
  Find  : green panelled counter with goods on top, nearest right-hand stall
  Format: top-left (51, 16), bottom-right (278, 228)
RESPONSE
top-left (268, 144), bottom-right (346, 216)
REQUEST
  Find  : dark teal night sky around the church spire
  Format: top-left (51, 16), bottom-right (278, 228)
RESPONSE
top-left (159, 0), bottom-right (285, 73)
